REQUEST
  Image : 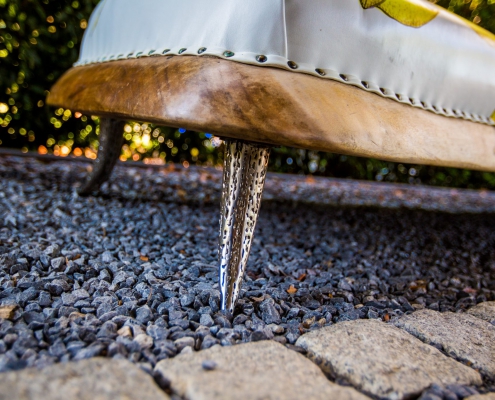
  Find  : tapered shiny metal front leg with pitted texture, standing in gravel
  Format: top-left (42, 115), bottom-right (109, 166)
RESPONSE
top-left (219, 140), bottom-right (270, 312)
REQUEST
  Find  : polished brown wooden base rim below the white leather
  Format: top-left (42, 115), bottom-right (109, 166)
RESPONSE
top-left (47, 56), bottom-right (495, 171)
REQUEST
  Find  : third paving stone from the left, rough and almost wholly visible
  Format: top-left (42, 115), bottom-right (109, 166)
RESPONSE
top-left (296, 320), bottom-right (481, 399)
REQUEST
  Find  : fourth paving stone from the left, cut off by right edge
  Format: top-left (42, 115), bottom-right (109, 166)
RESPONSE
top-left (396, 310), bottom-right (495, 379)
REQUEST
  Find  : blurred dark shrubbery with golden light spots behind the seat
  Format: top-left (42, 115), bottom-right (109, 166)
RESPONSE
top-left (0, 0), bottom-right (495, 189)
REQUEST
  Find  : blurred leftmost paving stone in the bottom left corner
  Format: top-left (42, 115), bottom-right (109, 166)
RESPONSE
top-left (0, 358), bottom-right (169, 400)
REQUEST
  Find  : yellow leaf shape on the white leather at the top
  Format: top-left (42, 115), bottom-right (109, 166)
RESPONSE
top-left (360, 0), bottom-right (438, 28)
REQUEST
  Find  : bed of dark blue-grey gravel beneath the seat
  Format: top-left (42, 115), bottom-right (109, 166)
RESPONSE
top-left (0, 157), bottom-right (495, 386)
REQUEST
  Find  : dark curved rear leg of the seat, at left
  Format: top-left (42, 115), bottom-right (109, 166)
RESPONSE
top-left (78, 118), bottom-right (125, 196)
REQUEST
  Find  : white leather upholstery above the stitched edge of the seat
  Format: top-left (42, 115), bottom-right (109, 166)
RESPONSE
top-left (76, 0), bottom-right (495, 124)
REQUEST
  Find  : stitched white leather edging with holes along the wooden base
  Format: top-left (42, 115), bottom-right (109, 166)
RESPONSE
top-left (74, 47), bottom-right (495, 126)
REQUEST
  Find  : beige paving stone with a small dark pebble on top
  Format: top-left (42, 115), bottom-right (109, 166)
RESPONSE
top-left (155, 342), bottom-right (367, 400)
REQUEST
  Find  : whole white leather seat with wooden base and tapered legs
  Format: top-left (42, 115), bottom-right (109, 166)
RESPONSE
top-left (48, 0), bottom-right (495, 311)
